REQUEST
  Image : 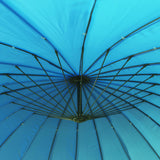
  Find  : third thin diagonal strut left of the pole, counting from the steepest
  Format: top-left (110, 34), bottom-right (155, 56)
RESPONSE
top-left (16, 66), bottom-right (74, 114)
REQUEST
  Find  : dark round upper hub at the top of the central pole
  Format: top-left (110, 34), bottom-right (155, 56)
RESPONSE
top-left (69, 75), bottom-right (90, 84)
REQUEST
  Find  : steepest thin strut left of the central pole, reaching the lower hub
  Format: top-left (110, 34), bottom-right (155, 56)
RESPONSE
top-left (55, 51), bottom-right (77, 114)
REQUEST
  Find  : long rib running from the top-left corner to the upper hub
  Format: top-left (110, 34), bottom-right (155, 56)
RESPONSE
top-left (1, 1), bottom-right (75, 74)
